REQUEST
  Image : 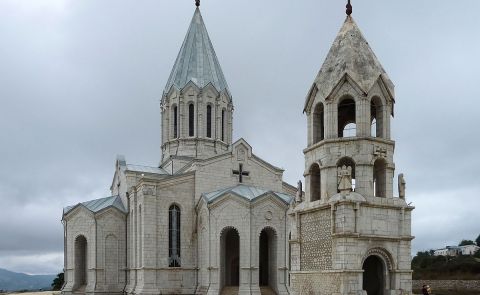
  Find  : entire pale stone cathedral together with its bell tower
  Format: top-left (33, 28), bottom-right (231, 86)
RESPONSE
top-left (62, 0), bottom-right (414, 295)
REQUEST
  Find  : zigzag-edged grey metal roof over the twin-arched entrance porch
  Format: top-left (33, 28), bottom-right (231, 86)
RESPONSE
top-left (202, 184), bottom-right (293, 204)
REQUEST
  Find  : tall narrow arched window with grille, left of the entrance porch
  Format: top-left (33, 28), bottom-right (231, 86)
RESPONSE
top-left (168, 205), bottom-right (181, 267)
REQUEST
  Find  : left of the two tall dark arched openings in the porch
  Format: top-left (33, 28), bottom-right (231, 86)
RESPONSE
top-left (220, 228), bottom-right (240, 288)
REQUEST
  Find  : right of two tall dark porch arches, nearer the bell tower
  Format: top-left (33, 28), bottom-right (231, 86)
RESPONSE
top-left (258, 227), bottom-right (277, 289)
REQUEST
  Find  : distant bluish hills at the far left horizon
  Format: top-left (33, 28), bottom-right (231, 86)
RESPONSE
top-left (0, 268), bottom-right (55, 291)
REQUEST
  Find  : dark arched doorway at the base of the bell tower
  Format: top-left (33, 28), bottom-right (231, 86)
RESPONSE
top-left (362, 255), bottom-right (385, 295)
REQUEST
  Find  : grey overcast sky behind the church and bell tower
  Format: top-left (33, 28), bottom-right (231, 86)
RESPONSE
top-left (0, 0), bottom-right (480, 274)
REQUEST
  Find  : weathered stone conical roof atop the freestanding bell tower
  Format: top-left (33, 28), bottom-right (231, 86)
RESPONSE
top-left (315, 16), bottom-right (394, 98)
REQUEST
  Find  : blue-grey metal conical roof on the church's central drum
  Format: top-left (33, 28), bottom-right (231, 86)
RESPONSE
top-left (165, 8), bottom-right (228, 93)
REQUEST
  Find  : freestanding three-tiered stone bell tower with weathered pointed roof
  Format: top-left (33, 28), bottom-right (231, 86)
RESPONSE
top-left (290, 1), bottom-right (414, 295)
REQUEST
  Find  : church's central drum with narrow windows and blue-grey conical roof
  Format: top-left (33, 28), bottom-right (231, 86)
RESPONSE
top-left (161, 1), bottom-right (233, 171)
